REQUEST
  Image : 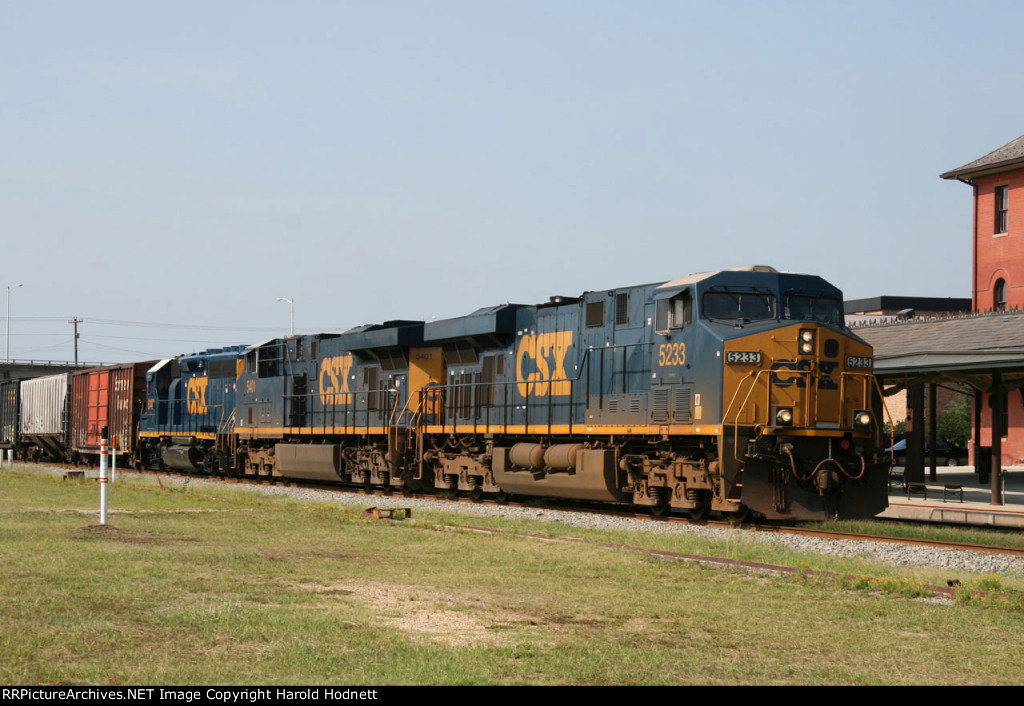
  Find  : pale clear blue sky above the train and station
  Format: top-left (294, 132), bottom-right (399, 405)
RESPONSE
top-left (0, 0), bottom-right (1024, 362)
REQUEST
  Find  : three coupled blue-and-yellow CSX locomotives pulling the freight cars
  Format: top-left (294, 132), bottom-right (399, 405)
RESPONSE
top-left (4, 266), bottom-right (890, 520)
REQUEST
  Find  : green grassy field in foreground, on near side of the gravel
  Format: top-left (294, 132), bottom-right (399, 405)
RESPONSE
top-left (0, 468), bottom-right (1024, 686)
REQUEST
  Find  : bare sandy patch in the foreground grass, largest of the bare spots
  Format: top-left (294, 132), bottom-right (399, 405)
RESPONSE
top-left (297, 581), bottom-right (529, 647)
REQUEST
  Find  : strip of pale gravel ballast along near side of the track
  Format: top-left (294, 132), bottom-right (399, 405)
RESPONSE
top-left (32, 466), bottom-right (1024, 575)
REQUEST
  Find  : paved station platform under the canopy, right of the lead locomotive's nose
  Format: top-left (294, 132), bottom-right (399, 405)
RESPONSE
top-left (879, 466), bottom-right (1024, 530)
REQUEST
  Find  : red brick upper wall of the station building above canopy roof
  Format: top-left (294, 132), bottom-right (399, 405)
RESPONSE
top-left (974, 169), bottom-right (1024, 312)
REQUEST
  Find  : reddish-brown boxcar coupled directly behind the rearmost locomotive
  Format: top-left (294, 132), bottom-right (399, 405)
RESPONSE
top-left (71, 361), bottom-right (157, 466)
